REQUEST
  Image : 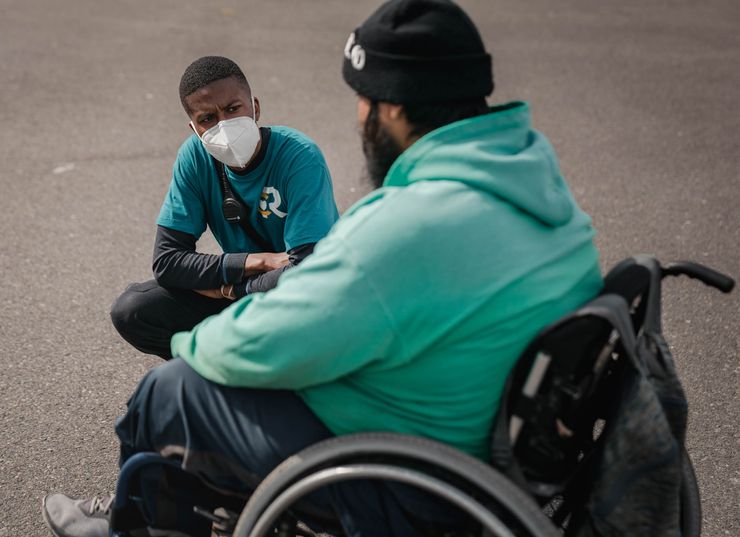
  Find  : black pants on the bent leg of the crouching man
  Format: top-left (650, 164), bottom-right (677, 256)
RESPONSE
top-left (110, 280), bottom-right (232, 360)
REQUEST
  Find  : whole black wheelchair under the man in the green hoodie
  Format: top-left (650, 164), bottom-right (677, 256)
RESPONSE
top-left (111, 255), bottom-right (734, 537)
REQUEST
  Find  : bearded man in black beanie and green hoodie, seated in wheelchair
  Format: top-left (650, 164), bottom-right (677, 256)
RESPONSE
top-left (43, 0), bottom-right (602, 537)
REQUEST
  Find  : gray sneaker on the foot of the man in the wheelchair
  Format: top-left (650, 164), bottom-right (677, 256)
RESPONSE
top-left (41, 494), bottom-right (115, 537)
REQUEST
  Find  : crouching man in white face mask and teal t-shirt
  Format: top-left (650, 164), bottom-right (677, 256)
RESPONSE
top-left (111, 56), bottom-right (338, 359)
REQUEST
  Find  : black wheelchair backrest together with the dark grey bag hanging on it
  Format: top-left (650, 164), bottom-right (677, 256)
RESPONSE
top-left (491, 256), bottom-right (686, 531)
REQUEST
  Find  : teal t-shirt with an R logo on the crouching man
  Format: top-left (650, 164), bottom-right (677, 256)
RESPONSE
top-left (157, 127), bottom-right (339, 253)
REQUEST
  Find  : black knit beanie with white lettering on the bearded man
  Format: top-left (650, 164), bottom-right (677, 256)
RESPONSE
top-left (342, 0), bottom-right (493, 104)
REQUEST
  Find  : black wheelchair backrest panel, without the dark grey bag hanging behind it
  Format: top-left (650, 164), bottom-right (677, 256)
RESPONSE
top-left (492, 294), bottom-right (635, 498)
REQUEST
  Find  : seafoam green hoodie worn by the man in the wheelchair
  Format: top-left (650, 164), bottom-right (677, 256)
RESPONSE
top-left (172, 103), bottom-right (601, 460)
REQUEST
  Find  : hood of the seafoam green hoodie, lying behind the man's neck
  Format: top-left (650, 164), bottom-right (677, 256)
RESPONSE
top-left (384, 102), bottom-right (575, 227)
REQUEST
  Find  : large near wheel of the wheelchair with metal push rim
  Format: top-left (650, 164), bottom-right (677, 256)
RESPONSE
top-left (234, 433), bottom-right (561, 537)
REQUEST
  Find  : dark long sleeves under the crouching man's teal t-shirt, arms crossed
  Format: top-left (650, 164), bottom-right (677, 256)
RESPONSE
top-left (152, 226), bottom-right (315, 298)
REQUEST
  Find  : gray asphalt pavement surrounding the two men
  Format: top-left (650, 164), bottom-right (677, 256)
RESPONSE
top-left (0, 0), bottom-right (740, 537)
